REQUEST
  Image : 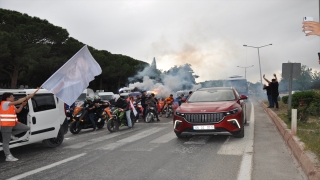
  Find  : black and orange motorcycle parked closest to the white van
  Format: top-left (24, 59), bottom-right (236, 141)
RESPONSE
top-left (69, 101), bottom-right (107, 134)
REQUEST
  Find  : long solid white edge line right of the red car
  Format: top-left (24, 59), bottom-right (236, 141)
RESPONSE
top-left (237, 103), bottom-right (254, 180)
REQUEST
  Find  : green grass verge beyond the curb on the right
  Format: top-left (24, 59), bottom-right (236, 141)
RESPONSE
top-left (265, 102), bottom-right (320, 161)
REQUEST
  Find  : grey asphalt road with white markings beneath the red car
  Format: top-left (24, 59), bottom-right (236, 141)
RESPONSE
top-left (0, 102), bottom-right (306, 180)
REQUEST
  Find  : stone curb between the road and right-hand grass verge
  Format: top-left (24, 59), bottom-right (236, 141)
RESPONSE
top-left (260, 102), bottom-right (320, 180)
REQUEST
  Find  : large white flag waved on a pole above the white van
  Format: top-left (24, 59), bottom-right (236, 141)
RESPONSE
top-left (41, 45), bottom-right (102, 105)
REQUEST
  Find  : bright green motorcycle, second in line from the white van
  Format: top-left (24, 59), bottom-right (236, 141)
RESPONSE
top-left (107, 108), bottom-right (136, 132)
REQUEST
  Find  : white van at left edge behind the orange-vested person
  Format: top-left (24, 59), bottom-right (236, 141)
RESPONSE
top-left (0, 89), bottom-right (68, 151)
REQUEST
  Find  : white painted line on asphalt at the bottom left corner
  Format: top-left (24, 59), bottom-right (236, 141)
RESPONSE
top-left (7, 153), bottom-right (86, 180)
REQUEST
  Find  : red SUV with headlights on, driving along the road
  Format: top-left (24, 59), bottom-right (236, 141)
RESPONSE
top-left (173, 87), bottom-right (248, 138)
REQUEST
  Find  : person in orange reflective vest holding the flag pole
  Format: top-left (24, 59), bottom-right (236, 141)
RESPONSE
top-left (0, 92), bottom-right (34, 161)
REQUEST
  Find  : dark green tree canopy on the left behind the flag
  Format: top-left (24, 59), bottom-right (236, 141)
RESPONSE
top-left (0, 9), bottom-right (147, 91)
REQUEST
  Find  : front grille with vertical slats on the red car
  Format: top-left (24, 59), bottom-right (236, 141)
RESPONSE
top-left (184, 113), bottom-right (224, 123)
